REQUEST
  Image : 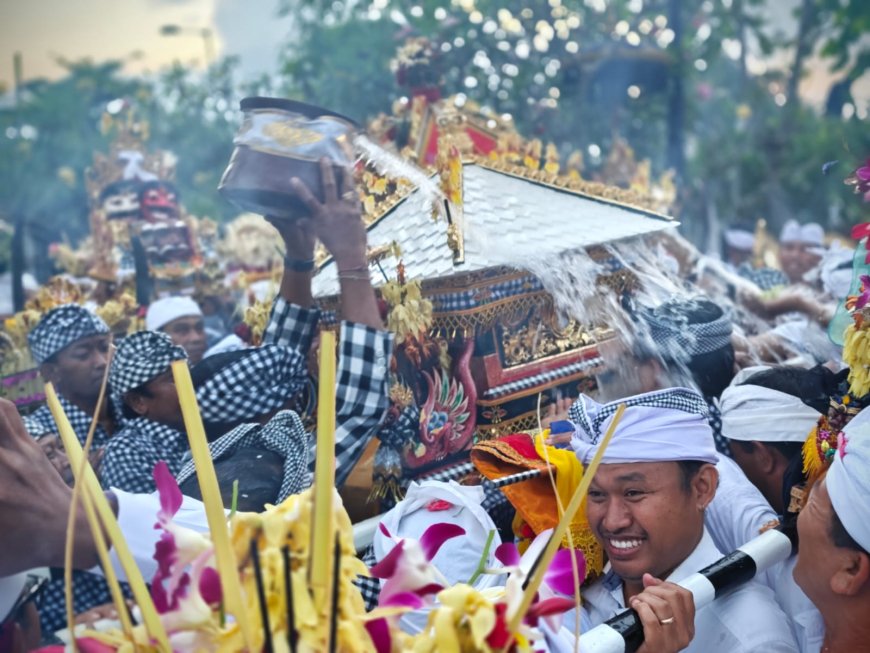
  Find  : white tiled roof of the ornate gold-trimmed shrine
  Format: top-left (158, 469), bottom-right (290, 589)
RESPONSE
top-left (313, 163), bottom-right (677, 297)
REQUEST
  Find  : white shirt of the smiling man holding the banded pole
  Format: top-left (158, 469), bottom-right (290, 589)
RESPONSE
top-left (545, 530), bottom-right (799, 653)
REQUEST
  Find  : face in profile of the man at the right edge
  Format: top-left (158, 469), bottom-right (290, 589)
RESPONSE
top-left (792, 479), bottom-right (840, 606)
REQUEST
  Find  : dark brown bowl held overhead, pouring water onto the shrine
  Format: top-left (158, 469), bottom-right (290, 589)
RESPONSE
top-left (218, 97), bottom-right (358, 219)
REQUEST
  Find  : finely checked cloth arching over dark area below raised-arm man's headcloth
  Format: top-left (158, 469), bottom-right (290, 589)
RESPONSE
top-left (177, 410), bottom-right (311, 503)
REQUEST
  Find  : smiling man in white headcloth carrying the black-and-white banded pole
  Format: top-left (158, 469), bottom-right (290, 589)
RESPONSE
top-left (571, 388), bottom-right (797, 653)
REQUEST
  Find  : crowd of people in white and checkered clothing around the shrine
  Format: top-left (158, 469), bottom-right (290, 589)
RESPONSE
top-left (0, 159), bottom-right (870, 653)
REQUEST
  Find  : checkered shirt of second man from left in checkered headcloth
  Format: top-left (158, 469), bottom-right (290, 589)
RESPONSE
top-left (100, 417), bottom-right (188, 494)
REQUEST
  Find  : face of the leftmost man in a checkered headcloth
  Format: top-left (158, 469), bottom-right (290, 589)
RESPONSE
top-left (43, 335), bottom-right (109, 402)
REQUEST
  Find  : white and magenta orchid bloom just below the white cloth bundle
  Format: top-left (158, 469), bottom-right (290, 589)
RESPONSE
top-left (370, 523), bottom-right (465, 608)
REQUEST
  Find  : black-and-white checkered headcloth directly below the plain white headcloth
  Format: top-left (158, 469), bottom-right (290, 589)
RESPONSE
top-left (109, 331), bottom-right (187, 397)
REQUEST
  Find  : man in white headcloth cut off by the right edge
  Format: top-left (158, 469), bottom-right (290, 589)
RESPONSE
top-left (794, 410), bottom-right (870, 653)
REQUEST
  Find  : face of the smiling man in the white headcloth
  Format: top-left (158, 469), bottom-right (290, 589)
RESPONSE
top-left (586, 462), bottom-right (717, 583)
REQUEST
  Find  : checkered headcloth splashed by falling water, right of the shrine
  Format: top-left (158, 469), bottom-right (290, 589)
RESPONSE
top-left (640, 301), bottom-right (732, 359)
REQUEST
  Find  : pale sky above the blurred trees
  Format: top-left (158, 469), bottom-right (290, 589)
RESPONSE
top-left (0, 0), bottom-right (870, 112)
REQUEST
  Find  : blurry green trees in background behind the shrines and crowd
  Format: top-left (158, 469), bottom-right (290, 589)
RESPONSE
top-left (0, 0), bottom-right (870, 274)
